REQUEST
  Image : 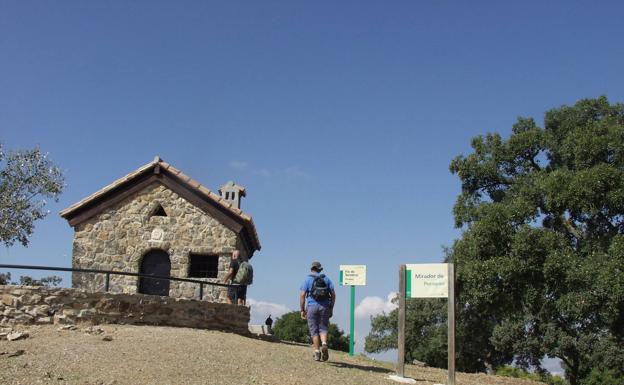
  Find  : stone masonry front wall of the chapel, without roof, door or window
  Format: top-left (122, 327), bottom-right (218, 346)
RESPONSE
top-left (72, 183), bottom-right (248, 302)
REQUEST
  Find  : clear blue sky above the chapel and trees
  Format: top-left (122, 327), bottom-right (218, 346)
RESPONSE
top-left (0, 0), bottom-right (624, 360)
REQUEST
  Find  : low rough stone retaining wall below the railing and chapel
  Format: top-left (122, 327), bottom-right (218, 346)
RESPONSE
top-left (0, 285), bottom-right (249, 334)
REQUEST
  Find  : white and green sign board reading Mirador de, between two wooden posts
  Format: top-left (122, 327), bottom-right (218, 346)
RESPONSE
top-left (405, 263), bottom-right (448, 298)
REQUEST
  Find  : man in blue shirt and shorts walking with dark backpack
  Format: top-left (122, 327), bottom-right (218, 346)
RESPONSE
top-left (299, 262), bottom-right (336, 361)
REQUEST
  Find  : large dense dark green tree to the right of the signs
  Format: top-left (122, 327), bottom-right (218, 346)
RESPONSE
top-left (449, 97), bottom-right (624, 385)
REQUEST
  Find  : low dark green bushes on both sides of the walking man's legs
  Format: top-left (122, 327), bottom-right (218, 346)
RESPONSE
top-left (273, 311), bottom-right (349, 352)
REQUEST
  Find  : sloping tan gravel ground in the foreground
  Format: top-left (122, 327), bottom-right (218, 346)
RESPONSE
top-left (0, 325), bottom-right (536, 385)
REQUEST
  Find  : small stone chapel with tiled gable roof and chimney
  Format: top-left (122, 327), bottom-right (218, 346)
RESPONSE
top-left (60, 156), bottom-right (260, 302)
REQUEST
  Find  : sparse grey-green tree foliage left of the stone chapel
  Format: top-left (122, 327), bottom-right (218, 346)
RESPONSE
top-left (0, 144), bottom-right (63, 246)
